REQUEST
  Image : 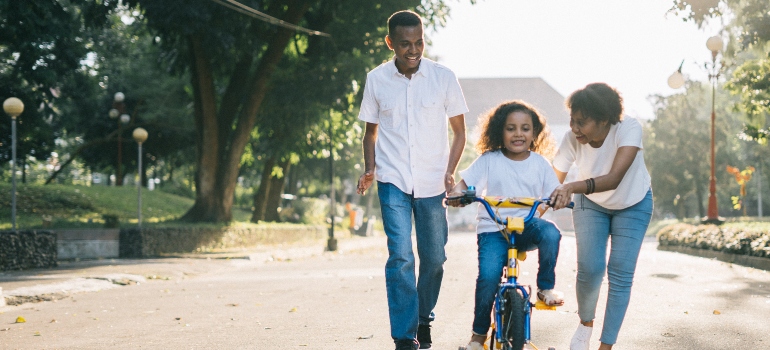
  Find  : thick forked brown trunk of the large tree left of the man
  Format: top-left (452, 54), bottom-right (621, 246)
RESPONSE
top-left (183, 1), bottom-right (309, 222)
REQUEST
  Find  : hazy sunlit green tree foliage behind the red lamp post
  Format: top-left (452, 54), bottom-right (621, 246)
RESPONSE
top-left (644, 82), bottom-right (754, 219)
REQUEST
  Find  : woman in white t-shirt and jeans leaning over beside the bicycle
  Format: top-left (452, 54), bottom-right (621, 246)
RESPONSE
top-left (551, 83), bottom-right (652, 350)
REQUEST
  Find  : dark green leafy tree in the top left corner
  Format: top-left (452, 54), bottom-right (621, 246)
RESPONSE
top-left (0, 0), bottom-right (117, 180)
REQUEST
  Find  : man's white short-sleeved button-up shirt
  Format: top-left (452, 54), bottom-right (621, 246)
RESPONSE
top-left (358, 58), bottom-right (468, 198)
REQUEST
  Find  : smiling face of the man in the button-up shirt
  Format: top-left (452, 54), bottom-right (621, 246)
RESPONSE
top-left (385, 26), bottom-right (425, 75)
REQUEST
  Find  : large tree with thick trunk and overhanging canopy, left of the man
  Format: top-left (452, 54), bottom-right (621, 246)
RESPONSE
top-left (128, 0), bottom-right (450, 221)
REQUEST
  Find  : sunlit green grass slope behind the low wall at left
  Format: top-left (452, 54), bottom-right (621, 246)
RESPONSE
top-left (0, 183), bottom-right (251, 230)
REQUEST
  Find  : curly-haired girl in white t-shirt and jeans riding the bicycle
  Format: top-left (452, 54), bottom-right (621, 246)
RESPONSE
top-left (447, 101), bottom-right (564, 350)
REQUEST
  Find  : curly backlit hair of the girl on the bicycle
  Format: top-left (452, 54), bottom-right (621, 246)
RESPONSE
top-left (476, 100), bottom-right (556, 159)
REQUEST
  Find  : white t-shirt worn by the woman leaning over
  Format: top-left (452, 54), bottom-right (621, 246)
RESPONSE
top-left (553, 117), bottom-right (650, 210)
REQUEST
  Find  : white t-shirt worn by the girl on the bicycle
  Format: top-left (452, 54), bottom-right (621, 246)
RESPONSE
top-left (460, 150), bottom-right (559, 233)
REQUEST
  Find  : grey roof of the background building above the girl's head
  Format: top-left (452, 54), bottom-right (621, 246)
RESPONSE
top-left (458, 78), bottom-right (570, 140)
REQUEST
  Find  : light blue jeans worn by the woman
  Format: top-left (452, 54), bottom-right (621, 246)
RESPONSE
top-left (572, 190), bottom-right (652, 344)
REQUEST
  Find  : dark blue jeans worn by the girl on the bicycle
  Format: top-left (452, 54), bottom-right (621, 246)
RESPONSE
top-left (473, 218), bottom-right (561, 334)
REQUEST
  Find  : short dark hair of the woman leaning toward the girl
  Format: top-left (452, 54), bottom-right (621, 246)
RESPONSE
top-left (567, 83), bottom-right (623, 125)
